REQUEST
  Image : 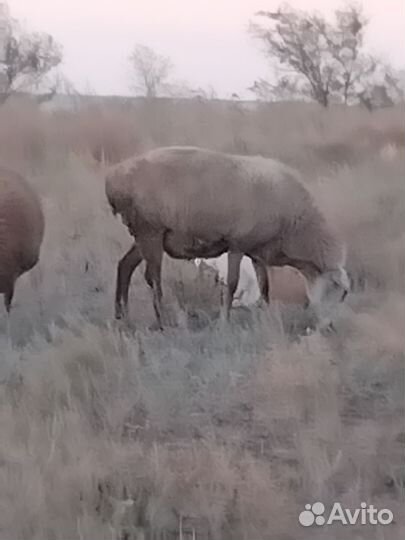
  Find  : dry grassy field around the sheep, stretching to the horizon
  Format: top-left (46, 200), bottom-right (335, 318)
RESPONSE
top-left (0, 101), bottom-right (405, 540)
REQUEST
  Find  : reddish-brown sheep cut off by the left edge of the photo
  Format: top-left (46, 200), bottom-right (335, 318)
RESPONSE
top-left (0, 168), bottom-right (44, 312)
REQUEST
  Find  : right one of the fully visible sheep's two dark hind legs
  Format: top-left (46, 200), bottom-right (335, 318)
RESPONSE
top-left (139, 235), bottom-right (163, 330)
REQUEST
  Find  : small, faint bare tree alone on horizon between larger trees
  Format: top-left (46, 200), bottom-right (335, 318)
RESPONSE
top-left (129, 44), bottom-right (173, 98)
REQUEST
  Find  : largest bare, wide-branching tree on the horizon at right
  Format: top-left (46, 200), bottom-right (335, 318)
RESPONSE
top-left (250, 4), bottom-right (400, 107)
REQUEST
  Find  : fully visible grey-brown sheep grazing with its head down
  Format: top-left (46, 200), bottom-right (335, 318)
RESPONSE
top-left (105, 147), bottom-right (349, 327)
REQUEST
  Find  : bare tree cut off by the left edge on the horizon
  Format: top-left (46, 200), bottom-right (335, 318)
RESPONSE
top-left (0, 10), bottom-right (62, 102)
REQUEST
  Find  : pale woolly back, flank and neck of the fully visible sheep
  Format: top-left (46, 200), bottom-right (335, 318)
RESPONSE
top-left (106, 147), bottom-right (341, 269)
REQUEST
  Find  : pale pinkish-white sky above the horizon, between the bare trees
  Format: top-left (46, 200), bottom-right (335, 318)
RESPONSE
top-left (6, 0), bottom-right (405, 97)
